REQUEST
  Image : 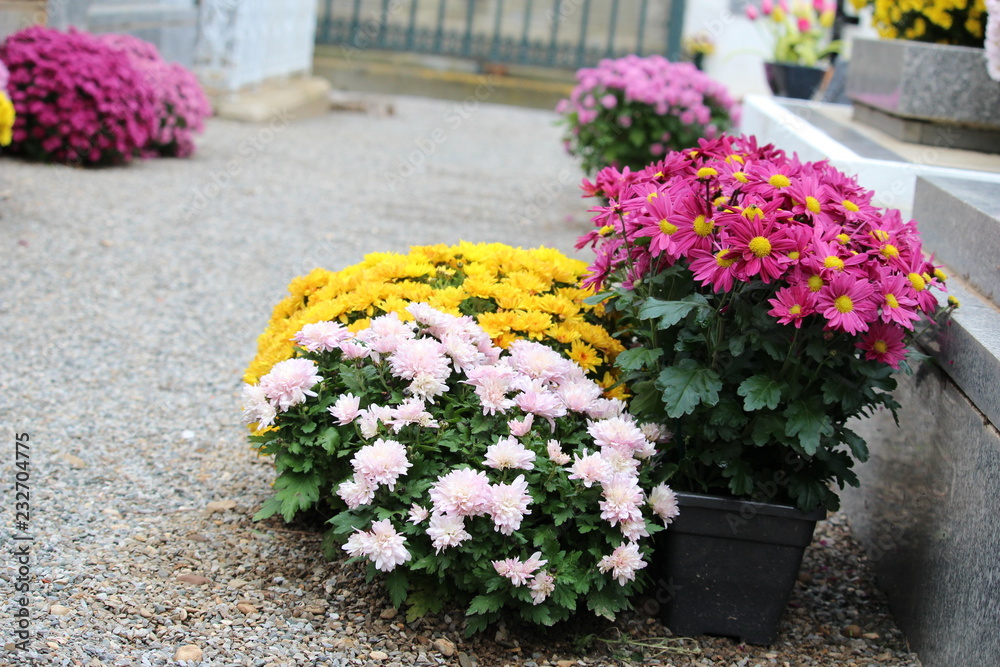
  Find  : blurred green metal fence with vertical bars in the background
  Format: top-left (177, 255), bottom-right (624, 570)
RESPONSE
top-left (317, 0), bottom-right (684, 69)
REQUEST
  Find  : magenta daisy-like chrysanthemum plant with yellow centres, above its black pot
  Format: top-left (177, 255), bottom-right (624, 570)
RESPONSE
top-left (579, 136), bottom-right (957, 510)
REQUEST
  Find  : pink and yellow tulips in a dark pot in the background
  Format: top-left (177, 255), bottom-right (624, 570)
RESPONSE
top-left (746, 0), bottom-right (841, 99)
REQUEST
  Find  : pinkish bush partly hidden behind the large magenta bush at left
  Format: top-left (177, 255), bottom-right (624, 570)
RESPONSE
top-left (99, 34), bottom-right (212, 157)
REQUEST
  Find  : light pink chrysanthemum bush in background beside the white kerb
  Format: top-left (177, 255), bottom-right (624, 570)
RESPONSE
top-left (556, 55), bottom-right (739, 174)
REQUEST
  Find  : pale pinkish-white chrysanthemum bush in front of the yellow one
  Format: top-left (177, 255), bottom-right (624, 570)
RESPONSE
top-left (243, 303), bottom-right (677, 633)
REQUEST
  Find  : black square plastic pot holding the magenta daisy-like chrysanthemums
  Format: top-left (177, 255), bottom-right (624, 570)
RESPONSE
top-left (650, 493), bottom-right (826, 645)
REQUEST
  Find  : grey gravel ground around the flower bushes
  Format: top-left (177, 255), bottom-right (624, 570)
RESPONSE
top-left (0, 98), bottom-right (919, 667)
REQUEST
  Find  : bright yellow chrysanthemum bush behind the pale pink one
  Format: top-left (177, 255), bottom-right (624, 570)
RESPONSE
top-left (244, 242), bottom-right (623, 398)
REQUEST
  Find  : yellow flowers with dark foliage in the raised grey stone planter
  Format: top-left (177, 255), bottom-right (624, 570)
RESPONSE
top-left (851, 0), bottom-right (986, 46)
